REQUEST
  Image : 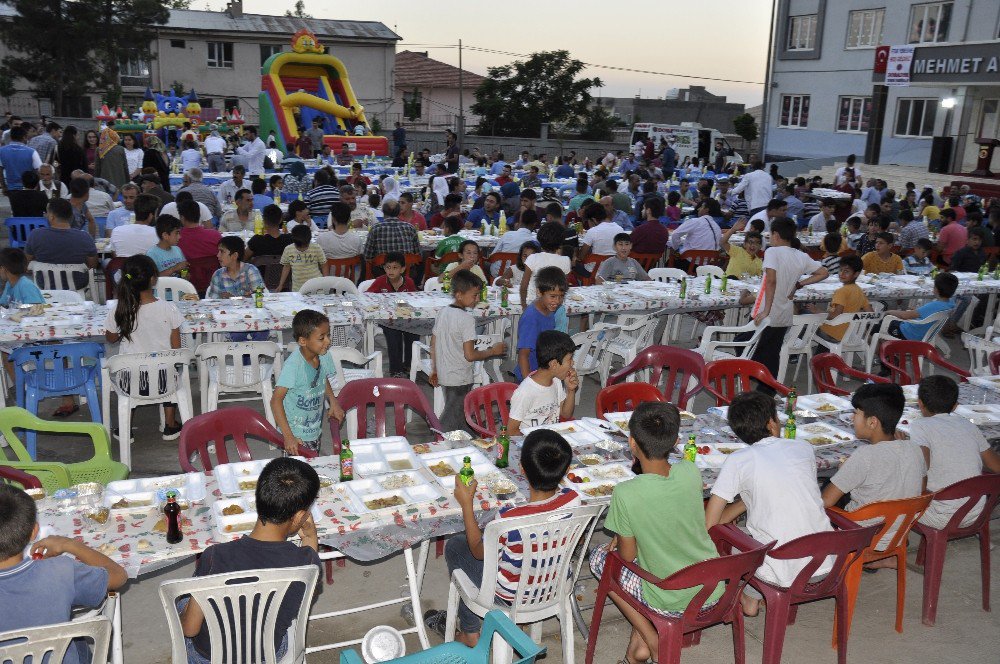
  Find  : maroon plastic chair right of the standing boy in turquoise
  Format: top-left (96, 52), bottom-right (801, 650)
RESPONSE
top-left (330, 378), bottom-right (441, 440)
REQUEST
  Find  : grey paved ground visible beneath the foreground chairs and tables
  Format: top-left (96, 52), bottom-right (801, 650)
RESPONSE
top-left (19, 320), bottom-right (1000, 664)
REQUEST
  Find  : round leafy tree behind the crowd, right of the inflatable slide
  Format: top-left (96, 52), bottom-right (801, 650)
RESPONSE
top-left (470, 51), bottom-right (603, 138)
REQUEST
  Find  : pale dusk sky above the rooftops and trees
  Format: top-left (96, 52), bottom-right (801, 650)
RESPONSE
top-left (234, 0), bottom-right (771, 106)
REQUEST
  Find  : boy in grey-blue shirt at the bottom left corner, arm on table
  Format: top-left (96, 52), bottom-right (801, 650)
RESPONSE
top-left (0, 482), bottom-right (128, 664)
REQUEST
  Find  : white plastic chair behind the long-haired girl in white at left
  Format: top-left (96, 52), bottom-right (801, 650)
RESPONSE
top-left (101, 348), bottom-right (194, 468)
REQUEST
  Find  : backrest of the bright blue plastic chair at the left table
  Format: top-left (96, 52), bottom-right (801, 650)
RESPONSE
top-left (10, 341), bottom-right (104, 394)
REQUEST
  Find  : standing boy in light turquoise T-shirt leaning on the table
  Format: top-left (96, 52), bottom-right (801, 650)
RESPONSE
top-left (271, 309), bottom-right (346, 454)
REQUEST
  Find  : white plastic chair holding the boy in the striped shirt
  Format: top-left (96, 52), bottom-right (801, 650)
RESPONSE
top-left (444, 505), bottom-right (602, 664)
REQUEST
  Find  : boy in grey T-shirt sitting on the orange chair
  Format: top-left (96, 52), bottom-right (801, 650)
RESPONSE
top-left (823, 383), bottom-right (927, 552)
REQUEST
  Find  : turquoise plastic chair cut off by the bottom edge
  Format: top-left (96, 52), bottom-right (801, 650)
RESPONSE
top-left (340, 611), bottom-right (545, 664)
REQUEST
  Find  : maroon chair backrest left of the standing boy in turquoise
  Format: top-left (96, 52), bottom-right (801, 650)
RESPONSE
top-left (177, 407), bottom-right (284, 475)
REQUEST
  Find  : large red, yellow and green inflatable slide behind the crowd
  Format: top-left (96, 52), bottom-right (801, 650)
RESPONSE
top-left (259, 29), bottom-right (389, 156)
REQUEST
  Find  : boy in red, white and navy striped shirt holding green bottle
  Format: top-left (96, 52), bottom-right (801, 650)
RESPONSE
top-left (424, 429), bottom-right (580, 647)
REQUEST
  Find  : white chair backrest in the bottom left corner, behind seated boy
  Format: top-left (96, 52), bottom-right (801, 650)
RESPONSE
top-left (0, 609), bottom-right (110, 664)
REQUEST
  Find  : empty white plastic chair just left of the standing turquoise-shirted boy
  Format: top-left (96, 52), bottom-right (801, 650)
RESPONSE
top-left (194, 341), bottom-right (281, 425)
